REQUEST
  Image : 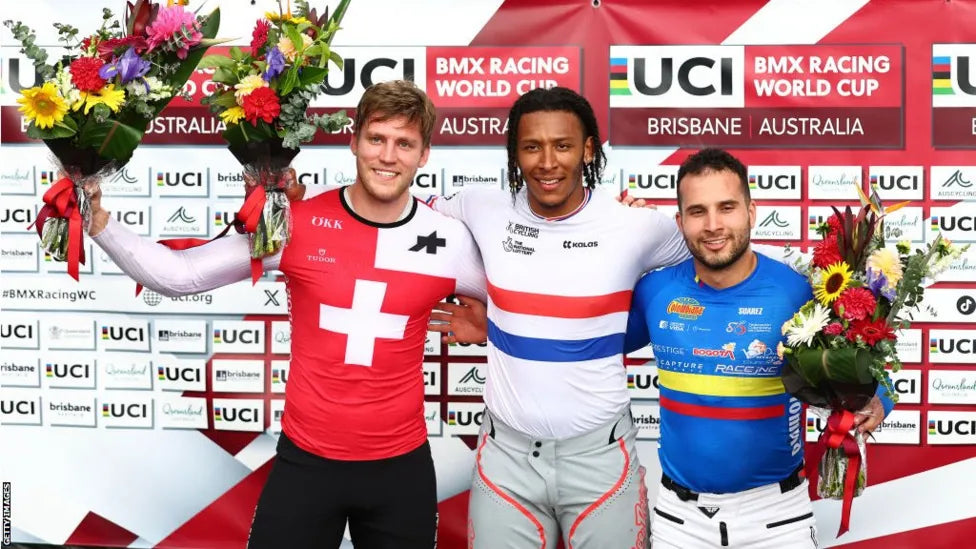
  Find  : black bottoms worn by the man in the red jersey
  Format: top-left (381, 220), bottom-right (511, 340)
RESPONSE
top-left (247, 433), bottom-right (437, 549)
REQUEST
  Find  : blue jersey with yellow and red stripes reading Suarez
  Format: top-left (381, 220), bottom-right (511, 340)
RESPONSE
top-left (626, 253), bottom-right (812, 493)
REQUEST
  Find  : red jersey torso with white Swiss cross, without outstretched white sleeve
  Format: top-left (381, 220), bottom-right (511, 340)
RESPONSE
top-left (280, 191), bottom-right (484, 460)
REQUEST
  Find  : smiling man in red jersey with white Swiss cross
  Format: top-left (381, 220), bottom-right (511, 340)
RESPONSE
top-left (90, 81), bottom-right (485, 549)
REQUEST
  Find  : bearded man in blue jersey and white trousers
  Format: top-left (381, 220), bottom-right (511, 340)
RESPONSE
top-left (626, 149), bottom-right (890, 549)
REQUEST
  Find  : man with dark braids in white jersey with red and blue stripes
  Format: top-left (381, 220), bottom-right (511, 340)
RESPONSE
top-left (424, 88), bottom-right (689, 549)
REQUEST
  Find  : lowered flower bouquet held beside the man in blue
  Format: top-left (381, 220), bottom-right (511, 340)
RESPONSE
top-left (778, 189), bottom-right (968, 535)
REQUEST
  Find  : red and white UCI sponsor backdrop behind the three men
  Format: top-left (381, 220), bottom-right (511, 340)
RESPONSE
top-left (0, 0), bottom-right (976, 549)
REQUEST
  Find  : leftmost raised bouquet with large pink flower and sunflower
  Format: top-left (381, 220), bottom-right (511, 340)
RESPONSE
top-left (4, 0), bottom-right (220, 280)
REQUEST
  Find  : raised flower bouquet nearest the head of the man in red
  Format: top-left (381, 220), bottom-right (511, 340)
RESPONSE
top-left (201, 0), bottom-right (349, 280)
